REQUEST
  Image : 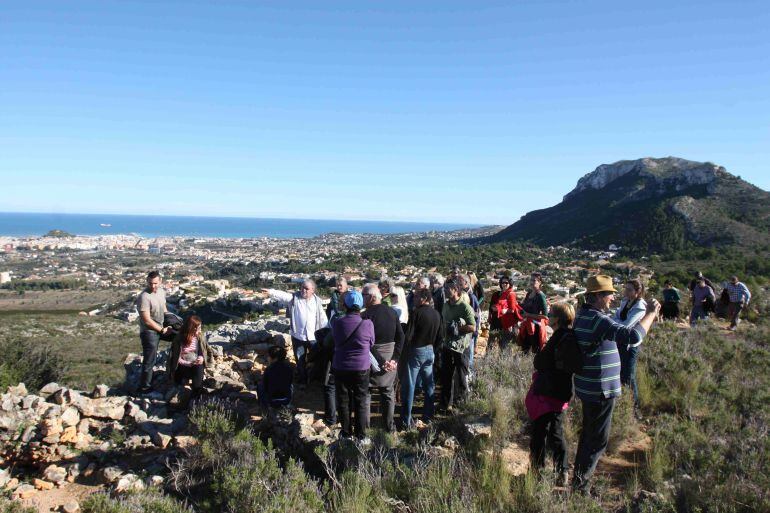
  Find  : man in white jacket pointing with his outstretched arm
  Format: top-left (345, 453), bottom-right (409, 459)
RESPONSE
top-left (262, 279), bottom-right (328, 386)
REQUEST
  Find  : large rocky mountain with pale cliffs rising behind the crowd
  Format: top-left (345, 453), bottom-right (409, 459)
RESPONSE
top-left (492, 157), bottom-right (770, 251)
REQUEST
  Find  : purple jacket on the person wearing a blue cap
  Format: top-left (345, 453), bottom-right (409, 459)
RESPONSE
top-left (332, 313), bottom-right (374, 371)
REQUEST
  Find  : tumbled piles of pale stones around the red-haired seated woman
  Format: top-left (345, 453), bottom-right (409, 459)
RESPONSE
top-left (0, 317), bottom-right (291, 499)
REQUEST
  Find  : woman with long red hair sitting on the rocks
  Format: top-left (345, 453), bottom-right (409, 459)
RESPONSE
top-left (167, 315), bottom-right (212, 397)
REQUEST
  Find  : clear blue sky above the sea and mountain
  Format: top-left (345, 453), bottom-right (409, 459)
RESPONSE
top-left (0, 0), bottom-right (770, 224)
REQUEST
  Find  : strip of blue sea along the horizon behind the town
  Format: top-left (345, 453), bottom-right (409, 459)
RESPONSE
top-left (0, 212), bottom-right (479, 238)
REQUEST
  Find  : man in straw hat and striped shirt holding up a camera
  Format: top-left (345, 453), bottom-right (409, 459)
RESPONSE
top-left (572, 275), bottom-right (660, 493)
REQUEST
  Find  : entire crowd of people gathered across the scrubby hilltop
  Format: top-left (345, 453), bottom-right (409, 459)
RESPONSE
top-left (137, 269), bottom-right (751, 491)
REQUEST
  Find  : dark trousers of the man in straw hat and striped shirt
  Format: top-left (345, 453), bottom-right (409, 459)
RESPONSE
top-left (572, 398), bottom-right (615, 491)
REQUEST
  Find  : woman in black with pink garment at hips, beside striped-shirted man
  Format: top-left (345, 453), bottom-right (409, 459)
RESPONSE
top-left (525, 303), bottom-right (577, 486)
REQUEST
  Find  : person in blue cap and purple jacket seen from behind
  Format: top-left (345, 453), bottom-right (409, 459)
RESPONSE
top-left (332, 290), bottom-right (374, 441)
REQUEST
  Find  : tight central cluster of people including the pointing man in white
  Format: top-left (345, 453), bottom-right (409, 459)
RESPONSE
top-left (265, 270), bottom-right (481, 441)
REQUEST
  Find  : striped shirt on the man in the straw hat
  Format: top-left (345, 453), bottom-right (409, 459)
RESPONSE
top-left (574, 305), bottom-right (646, 402)
